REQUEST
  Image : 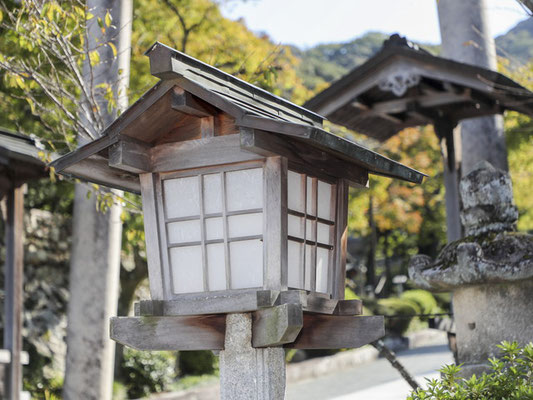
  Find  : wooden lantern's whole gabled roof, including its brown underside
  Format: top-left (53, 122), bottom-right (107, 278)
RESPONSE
top-left (53, 42), bottom-right (424, 192)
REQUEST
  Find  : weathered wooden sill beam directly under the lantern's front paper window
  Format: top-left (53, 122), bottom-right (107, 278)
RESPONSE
top-left (134, 290), bottom-right (279, 316)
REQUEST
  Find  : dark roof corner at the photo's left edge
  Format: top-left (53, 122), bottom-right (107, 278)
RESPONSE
top-left (0, 128), bottom-right (46, 198)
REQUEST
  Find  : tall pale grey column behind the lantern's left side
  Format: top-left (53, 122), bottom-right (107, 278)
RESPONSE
top-left (63, 0), bottom-right (132, 400)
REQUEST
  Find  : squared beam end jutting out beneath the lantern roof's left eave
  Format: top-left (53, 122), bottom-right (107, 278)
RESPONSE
top-left (109, 135), bottom-right (152, 174)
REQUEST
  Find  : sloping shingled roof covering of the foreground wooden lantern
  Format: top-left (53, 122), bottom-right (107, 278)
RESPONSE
top-left (54, 42), bottom-right (424, 191)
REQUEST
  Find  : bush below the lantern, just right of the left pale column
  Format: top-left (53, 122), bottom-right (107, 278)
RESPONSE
top-left (122, 348), bottom-right (176, 399)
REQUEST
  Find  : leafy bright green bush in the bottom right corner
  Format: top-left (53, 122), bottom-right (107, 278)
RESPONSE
top-left (408, 342), bottom-right (533, 400)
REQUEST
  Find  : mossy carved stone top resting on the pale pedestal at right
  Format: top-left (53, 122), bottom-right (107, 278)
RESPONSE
top-left (409, 162), bottom-right (533, 290)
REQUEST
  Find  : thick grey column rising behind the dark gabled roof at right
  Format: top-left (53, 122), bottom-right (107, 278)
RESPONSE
top-left (437, 0), bottom-right (508, 176)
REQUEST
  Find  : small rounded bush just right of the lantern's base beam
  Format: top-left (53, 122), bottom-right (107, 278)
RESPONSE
top-left (375, 297), bottom-right (421, 336)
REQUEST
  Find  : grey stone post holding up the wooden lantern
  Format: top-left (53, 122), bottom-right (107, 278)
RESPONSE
top-left (220, 314), bottom-right (285, 400)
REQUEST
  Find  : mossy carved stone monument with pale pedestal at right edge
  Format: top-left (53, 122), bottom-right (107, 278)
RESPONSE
top-left (409, 162), bottom-right (533, 376)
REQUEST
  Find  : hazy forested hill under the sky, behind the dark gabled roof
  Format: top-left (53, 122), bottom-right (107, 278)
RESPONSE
top-left (292, 18), bottom-right (533, 91)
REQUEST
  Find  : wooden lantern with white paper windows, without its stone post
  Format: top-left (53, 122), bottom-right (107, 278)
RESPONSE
top-left (54, 43), bottom-right (423, 398)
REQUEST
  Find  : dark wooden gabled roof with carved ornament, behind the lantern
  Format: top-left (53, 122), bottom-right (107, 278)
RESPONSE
top-left (304, 35), bottom-right (533, 141)
